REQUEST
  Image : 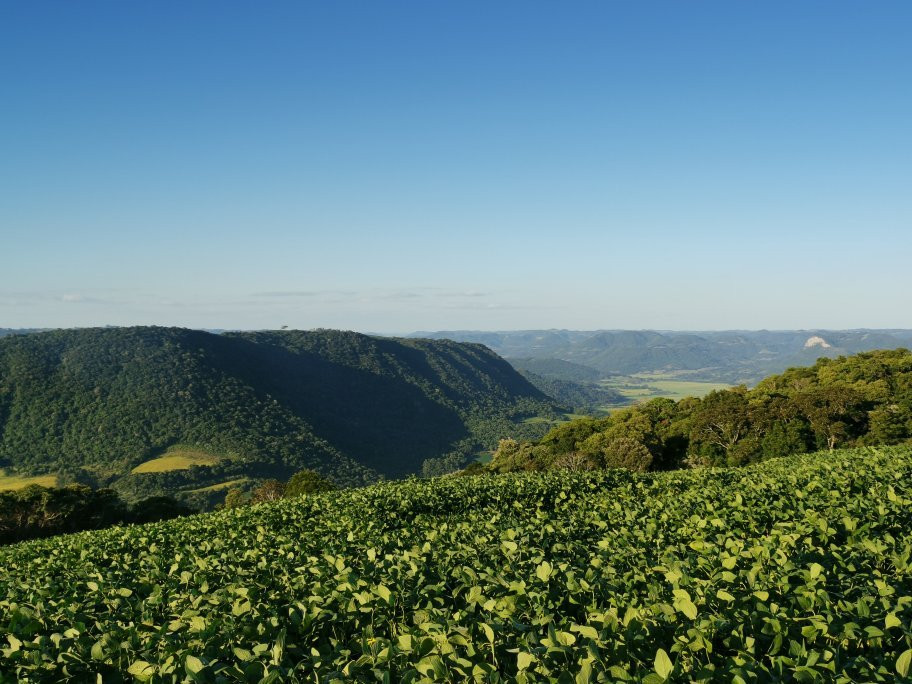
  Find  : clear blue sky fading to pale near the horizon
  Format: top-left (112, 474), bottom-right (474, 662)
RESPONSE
top-left (0, 0), bottom-right (912, 332)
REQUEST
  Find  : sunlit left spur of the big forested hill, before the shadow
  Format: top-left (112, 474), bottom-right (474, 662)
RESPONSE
top-left (0, 328), bottom-right (367, 486)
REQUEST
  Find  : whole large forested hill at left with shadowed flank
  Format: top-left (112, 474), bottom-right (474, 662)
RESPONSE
top-left (0, 327), bottom-right (555, 504)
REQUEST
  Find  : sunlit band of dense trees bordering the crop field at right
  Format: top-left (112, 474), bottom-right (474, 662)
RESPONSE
top-left (489, 349), bottom-right (912, 472)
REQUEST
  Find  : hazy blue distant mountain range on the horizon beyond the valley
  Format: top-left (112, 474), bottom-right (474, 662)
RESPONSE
top-left (415, 329), bottom-right (912, 384)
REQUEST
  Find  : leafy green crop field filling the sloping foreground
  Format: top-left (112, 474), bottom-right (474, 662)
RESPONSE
top-left (0, 448), bottom-right (912, 683)
